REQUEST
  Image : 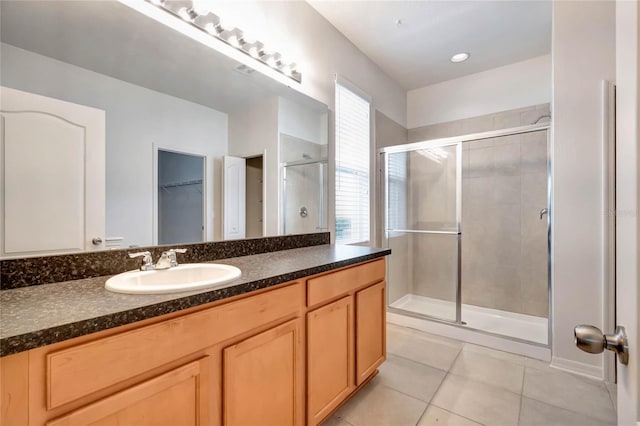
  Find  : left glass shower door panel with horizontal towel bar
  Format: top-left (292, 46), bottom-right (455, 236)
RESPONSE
top-left (382, 142), bottom-right (462, 322)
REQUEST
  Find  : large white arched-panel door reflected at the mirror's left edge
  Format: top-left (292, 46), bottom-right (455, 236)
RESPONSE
top-left (0, 87), bottom-right (105, 258)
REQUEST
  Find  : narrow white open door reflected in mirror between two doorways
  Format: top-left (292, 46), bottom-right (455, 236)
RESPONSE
top-left (222, 155), bottom-right (247, 240)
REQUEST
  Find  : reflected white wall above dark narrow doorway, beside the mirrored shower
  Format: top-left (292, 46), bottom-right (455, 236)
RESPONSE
top-left (229, 96), bottom-right (280, 237)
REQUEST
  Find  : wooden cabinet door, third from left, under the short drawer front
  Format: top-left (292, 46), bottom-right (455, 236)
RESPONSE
top-left (307, 296), bottom-right (355, 425)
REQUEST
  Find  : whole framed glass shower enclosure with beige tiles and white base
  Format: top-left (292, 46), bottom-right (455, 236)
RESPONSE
top-left (380, 125), bottom-right (550, 345)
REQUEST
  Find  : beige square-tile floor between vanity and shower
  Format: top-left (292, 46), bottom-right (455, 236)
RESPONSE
top-left (324, 324), bottom-right (616, 426)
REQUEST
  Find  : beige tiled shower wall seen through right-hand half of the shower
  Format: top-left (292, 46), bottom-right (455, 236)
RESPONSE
top-left (462, 131), bottom-right (549, 317)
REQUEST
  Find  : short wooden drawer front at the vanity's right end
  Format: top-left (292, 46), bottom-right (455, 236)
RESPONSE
top-left (307, 259), bottom-right (386, 306)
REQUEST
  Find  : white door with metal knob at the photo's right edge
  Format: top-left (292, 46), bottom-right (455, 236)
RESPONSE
top-left (616, 1), bottom-right (640, 426)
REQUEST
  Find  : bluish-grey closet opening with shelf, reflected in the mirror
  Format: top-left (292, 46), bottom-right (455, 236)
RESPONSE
top-left (158, 149), bottom-right (205, 245)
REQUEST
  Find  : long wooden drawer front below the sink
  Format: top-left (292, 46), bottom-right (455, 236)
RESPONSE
top-left (46, 284), bottom-right (304, 409)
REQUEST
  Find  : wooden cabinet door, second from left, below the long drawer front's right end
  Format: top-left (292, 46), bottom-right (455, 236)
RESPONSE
top-left (222, 319), bottom-right (304, 426)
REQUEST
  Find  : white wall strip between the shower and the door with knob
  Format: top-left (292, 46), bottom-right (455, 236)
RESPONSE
top-left (551, 1), bottom-right (616, 376)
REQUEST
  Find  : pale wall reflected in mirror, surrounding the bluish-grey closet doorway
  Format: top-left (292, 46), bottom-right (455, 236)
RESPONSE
top-left (0, 44), bottom-right (227, 246)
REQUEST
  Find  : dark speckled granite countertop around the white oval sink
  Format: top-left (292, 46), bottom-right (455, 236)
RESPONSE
top-left (0, 245), bottom-right (391, 356)
